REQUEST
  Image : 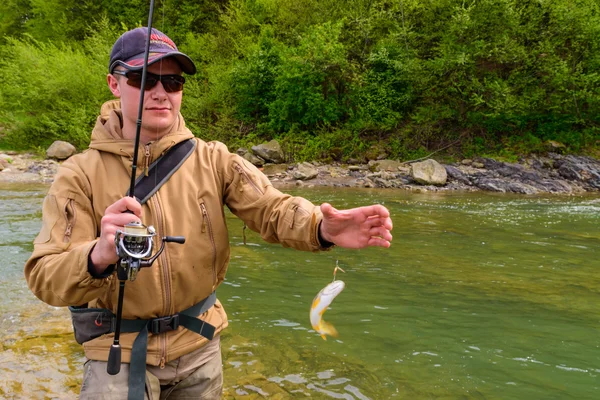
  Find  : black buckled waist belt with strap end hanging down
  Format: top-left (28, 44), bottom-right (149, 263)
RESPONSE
top-left (119, 292), bottom-right (217, 400)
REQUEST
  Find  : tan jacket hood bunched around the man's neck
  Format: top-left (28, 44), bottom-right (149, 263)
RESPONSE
top-left (89, 100), bottom-right (194, 165)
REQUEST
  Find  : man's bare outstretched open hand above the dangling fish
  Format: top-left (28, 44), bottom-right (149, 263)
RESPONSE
top-left (321, 203), bottom-right (393, 249)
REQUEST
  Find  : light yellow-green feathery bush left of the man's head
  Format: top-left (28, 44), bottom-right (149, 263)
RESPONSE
top-left (0, 20), bottom-right (114, 149)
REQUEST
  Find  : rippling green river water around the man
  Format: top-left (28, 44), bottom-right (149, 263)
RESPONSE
top-left (0, 186), bottom-right (600, 399)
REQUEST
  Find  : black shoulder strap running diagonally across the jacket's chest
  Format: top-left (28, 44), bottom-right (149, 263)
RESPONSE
top-left (127, 139), bottom-right (196, 204)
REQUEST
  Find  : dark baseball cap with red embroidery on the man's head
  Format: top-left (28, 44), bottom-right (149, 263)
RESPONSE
top-left (108, 27), bottom-right (196, 75)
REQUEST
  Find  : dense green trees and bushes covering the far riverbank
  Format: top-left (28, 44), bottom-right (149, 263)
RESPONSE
top-left (0, 0), bottom-right (600, 161)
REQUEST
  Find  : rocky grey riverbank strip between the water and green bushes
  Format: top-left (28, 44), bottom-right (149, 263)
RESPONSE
top-left (0, 152), bottom-right (600, 194)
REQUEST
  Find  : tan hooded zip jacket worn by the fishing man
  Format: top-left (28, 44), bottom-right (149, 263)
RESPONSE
top-left (25, 101), bottom-right (322, 365)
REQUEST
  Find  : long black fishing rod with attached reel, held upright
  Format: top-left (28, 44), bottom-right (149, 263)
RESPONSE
top-left (106, 0), bottom-right (185, 375)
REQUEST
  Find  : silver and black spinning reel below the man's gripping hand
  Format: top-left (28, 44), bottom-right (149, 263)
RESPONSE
top-left (115, 222), bottom-right (185, 282)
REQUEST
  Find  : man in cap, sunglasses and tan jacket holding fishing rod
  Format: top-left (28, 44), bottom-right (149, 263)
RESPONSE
top-left (25, 28), bottom-right (392, 399)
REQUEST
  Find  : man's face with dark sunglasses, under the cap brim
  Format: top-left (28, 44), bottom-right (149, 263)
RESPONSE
top-left (107, 58), bottom-right (183, 143)
